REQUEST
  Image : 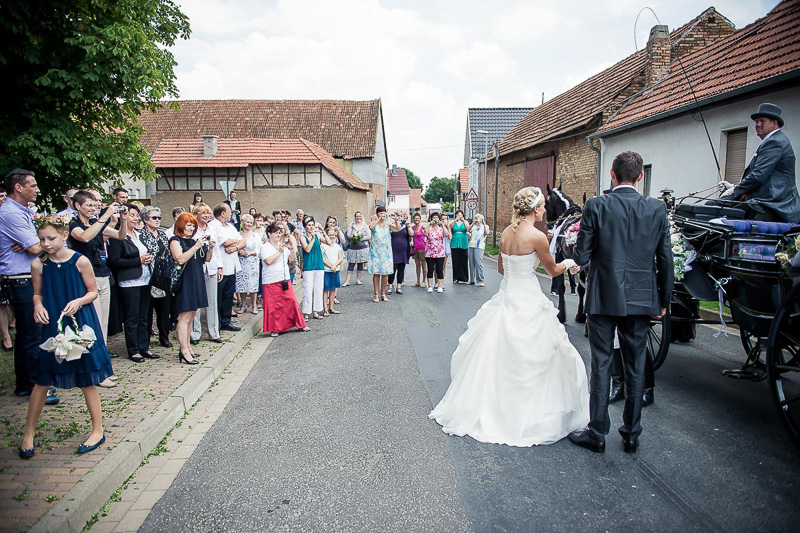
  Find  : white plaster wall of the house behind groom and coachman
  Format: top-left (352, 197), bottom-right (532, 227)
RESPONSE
top-left (600, 88), bottom-right (800, 196)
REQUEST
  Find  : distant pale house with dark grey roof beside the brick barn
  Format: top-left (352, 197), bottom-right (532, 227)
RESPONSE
top-left (464, 107), bottom-right (533, 216)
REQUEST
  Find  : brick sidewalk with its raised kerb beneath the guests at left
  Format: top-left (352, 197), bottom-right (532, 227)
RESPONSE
top-left (0, 313), bottom-right (263, 532)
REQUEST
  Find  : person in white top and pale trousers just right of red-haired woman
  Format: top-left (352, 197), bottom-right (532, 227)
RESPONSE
top-left (189, 204), bottom-right (222, 344)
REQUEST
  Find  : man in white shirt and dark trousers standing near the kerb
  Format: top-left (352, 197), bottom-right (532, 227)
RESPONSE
top-left (209, 202), bottom-right (246, 331)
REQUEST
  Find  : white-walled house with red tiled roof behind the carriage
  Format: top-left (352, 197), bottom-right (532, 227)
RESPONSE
top-left (592, 0), bottom-right (800, 200)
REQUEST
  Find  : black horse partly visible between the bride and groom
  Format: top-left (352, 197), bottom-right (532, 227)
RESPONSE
top-left (544, 184), bottom-right (586, 324)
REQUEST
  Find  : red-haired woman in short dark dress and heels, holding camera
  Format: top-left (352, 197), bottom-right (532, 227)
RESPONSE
top-left (169, 213), bottom-right (212, 365)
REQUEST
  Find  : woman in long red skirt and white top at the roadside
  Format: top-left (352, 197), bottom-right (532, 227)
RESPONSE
top-left (261, 223), bottom-right (310, 337)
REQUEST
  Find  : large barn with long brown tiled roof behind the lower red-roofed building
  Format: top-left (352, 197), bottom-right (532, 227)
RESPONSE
top-left (127, 99), bottom-right (389, 210)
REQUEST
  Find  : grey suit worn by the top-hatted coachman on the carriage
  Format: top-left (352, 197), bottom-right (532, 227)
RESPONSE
top-left (731, 130), bottom-right (800, 224)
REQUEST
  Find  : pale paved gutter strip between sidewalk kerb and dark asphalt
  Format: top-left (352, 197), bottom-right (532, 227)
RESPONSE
top-left (83, 337), bottom-right (272, 533)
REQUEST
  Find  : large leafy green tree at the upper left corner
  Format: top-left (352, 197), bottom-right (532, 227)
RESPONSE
top-left (0, 0), bottom-right (190, 203)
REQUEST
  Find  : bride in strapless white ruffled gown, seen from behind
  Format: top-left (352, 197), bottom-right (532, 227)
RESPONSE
top-left (428, 187), bottom-right (589, 446)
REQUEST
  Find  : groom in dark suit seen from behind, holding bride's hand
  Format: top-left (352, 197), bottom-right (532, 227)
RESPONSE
top-left (569, 152), bottom-right (674, 453)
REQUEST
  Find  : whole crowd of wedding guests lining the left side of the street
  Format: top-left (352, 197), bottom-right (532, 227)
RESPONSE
top-left (0, 169), bottom-right (487, 457)
